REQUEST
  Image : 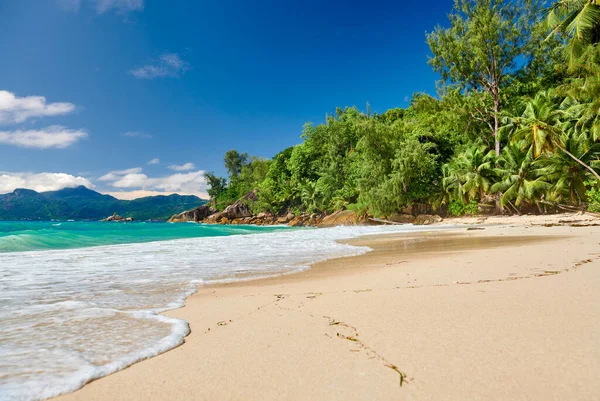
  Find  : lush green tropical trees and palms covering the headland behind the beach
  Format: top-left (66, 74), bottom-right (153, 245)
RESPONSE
top-left (207, 0), bottom-right (600, 216)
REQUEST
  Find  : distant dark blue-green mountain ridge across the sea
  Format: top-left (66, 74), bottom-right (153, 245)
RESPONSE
top-left (0, 186), bottom-right (206, 220)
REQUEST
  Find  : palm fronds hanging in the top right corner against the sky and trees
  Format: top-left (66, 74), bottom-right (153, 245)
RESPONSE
top-left (546, 0), bottom-right (600, 67)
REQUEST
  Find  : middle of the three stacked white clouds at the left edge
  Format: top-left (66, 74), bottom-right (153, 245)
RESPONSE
top-left (0, 125), bottom-right (88, 149)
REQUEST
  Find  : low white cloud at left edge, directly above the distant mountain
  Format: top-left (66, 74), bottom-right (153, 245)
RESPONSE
top-left (0, 172), bottom-right (94, 193)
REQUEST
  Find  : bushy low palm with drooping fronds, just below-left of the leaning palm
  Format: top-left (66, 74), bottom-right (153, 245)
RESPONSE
top-left (491, 142), bottom-right (551, 209)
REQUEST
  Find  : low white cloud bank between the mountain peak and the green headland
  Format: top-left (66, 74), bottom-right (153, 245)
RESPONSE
top-left (99, 167), bottom-right (206, 194)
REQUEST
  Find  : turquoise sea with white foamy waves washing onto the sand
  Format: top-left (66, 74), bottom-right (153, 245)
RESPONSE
top-left (0, 222), bottom-right (450, 401)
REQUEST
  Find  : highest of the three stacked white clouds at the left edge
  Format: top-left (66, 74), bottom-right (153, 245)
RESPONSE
top-left (0, 90), bottom-right (75, 124)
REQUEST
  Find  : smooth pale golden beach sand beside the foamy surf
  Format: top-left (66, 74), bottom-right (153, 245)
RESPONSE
top-left (58, 216), bottom-right (600, 401)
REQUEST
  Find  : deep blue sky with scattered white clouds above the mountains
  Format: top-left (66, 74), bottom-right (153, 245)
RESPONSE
top-left (0, 0), bottom-right (453, 199)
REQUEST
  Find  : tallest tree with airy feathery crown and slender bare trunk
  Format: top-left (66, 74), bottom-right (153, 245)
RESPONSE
top-left (427, 0), bottom-right (540, 155)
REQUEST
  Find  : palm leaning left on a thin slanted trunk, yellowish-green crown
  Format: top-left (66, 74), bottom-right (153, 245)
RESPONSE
top-left (503, 92), bottom-right (600, 181)
